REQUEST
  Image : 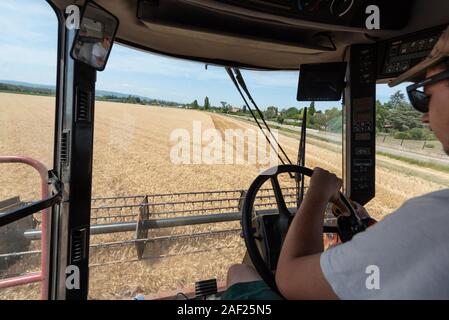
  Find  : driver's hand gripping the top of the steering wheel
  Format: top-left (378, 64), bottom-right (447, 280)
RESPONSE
top-left (309, 167), bottom-right (343, 203)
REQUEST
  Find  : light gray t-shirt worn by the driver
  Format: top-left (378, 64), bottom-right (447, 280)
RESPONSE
top-left (320, 189), bottom-right (449, 299)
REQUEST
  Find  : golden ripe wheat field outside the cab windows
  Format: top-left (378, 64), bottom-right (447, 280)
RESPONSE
top-left (0, 93), bottom-right (449, 299)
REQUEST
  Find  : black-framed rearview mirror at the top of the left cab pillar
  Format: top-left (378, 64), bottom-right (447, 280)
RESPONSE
top-left (71, 1), bottom-right (119, 71)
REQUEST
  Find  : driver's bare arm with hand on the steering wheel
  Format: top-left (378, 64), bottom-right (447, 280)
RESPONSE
top-left (276, 168), bottom-right (342, 299)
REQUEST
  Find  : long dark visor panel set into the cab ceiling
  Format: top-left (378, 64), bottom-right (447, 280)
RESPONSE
top-left (137, 1), bottom-right (336, 54)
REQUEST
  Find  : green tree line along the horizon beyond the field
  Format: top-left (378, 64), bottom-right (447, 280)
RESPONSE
top-left (0, 83), bottom-right (436, 140)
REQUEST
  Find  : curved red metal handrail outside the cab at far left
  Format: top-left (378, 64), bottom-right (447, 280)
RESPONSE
top-left (0, 156), bottom-right (49, 300)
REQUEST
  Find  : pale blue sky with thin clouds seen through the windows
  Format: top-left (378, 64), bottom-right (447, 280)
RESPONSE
top-left (0, 0), bottom-right (405, 109)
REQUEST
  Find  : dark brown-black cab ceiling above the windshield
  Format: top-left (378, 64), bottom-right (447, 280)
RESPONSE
top-left (47, 0), bottom-right (449, 70)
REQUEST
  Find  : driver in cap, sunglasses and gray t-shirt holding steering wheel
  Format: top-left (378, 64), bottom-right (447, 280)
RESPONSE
top-left (223, 28), bottom-right (449, 299)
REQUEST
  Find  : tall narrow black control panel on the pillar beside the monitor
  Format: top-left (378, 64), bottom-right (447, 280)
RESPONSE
top-left (345, 45), bottom-right (377, 205)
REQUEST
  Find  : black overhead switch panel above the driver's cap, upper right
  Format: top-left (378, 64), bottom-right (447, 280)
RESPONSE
top-left (378, 27), bottom-right (445, 79)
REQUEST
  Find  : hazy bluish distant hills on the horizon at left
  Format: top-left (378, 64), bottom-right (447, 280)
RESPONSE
top-left (0, 80), bottom-right (183, 106)
